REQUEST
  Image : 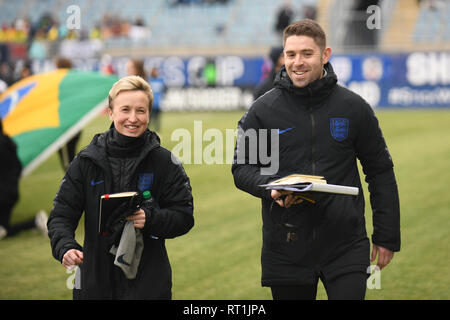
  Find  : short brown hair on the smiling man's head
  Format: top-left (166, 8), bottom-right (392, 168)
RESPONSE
top-left (283, 19), bottom-right (327, 50)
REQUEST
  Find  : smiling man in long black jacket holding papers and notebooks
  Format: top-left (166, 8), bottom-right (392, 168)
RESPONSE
top-left (232, 20), bottom-right (400, 299)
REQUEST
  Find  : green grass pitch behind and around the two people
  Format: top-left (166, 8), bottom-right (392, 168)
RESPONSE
top-left (0, 110), bottom-right (450, 300)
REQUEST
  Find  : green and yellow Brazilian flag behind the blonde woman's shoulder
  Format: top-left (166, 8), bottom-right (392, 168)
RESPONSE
top-left (0, 69), bottom-right (118, 176)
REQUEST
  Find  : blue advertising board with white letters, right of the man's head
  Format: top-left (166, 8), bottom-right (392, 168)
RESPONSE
top-left (331, 51), bottom-right (450, 108)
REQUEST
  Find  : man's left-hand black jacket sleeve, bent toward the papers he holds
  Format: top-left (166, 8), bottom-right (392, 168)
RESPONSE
top-left (231, 108), bottom-right (278, 200)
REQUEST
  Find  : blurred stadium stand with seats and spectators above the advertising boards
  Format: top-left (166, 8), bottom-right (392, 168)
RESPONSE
top-left (0, 0), bottom-right (450, 64)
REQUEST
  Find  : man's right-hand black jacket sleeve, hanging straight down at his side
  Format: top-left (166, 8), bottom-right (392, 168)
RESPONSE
top-left (356, 102), bottom-right (401, 251)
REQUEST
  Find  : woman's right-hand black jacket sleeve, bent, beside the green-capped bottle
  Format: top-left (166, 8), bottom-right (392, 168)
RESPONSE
top-left (144, 154), bottom-right (194, 238)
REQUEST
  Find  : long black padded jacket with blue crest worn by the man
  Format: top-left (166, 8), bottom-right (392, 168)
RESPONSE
top-left (232, 63), bottom-right (400, 286)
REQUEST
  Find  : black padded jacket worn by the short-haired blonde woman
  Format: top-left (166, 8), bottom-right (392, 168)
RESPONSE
top-left (48, 128), bottom-right (194, 299)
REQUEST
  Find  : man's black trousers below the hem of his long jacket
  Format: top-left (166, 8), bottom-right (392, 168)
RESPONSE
top-left (270, 272), bottom-right (368, 300)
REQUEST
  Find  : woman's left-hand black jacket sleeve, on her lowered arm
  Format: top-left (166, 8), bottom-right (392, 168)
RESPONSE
top-left (47, 157), bottom-right (85, 262)
